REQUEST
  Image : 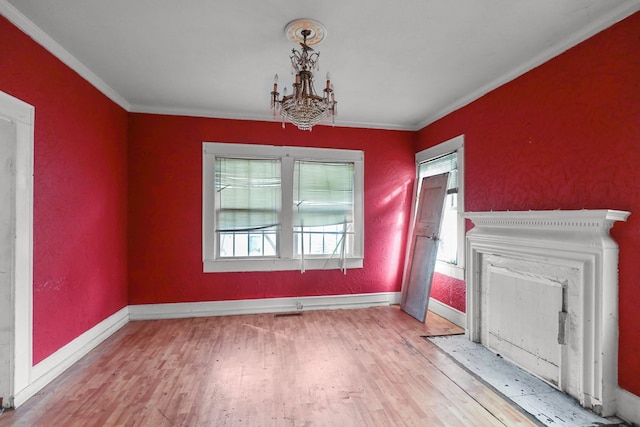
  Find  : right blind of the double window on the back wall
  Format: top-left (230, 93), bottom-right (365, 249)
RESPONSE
top-left (293, 160), bottom-right (354, 228)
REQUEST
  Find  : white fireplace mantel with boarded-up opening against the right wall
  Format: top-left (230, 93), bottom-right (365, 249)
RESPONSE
top-left (465, 210), bottom-right (630, 416)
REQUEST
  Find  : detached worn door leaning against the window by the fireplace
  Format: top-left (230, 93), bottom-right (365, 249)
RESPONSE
top-left (400, 172), bottom-right (449, 322)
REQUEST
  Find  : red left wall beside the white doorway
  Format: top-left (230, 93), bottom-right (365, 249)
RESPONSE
top-left (0, 16), bottom-right (127, 364)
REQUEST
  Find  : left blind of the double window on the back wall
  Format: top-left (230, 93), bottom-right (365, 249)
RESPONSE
top-left (215, 157), bottom-right (281, 232)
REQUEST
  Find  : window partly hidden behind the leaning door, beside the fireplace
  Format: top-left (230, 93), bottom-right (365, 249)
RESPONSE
top-left (416, 136), bottom-right (464, 279)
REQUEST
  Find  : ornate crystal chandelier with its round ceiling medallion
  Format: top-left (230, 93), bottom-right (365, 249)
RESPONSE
top-left (271, 19), bottom-right (338, 131)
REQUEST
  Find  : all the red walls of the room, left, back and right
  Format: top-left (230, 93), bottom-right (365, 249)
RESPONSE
top-left (0, 5), bottom-right (640, 402)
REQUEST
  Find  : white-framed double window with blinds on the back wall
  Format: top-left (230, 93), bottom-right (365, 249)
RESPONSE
top-left (202, 142), bottom-right (364, 272)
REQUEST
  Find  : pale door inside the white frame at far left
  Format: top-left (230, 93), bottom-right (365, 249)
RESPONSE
top-left (0, 116), bottom-right (16, 404)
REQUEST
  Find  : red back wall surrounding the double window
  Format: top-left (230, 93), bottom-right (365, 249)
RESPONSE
top-left (129, 114), bottom-right (415, 304)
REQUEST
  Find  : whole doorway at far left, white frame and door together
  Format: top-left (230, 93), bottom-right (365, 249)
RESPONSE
top-left (0, 92), bottom-right (34, 407)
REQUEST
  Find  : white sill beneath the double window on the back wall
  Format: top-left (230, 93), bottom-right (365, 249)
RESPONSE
top-left (203, 258), bottom-right (363, 273)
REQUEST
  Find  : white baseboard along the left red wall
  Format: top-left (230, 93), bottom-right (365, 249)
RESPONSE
top-left (13, 307), bottom-right (129, 408)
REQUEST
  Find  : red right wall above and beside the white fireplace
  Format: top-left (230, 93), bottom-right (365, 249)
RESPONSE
top-left (417, 13), bottom-right (640, 395)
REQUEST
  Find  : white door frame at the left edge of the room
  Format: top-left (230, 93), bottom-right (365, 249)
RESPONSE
top-left (0, 91), bottom-right (35, 406)
